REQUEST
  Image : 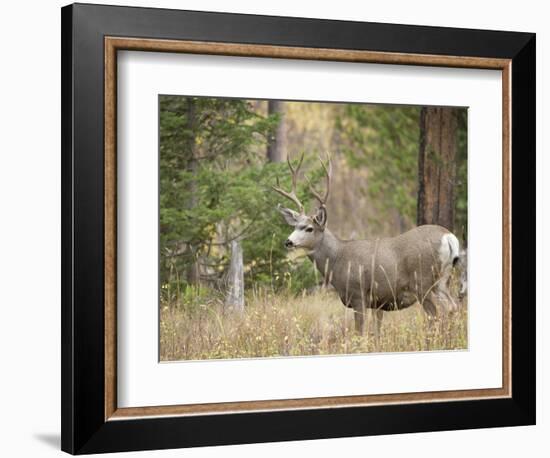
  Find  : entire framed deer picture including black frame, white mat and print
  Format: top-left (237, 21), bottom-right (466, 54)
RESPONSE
top-left (62, 4), bottom-right (535, 454)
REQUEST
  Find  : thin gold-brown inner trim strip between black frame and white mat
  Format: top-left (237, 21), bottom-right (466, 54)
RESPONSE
top-left (104, 37), bottom-right (512, 421)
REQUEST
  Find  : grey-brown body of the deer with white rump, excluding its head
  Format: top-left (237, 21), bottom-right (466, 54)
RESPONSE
top-left (309, 225), bottom-right (458, 331)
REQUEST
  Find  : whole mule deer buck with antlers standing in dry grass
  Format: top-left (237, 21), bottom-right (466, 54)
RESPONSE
top-left (273, 155), bottom-right (459, 336)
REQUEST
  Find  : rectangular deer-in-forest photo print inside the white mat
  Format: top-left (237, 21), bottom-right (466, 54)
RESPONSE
top-left (159, 95), bottom-right (468, 361)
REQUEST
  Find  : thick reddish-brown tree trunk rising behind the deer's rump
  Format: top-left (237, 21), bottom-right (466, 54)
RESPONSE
top-left (417, 107), bottom-right (457, 231)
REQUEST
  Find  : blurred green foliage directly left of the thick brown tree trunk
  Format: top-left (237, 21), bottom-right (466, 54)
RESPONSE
top-left (337, 104), bottom-right (420, 222)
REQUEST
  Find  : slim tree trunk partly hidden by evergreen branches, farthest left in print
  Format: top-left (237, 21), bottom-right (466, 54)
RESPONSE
top-left (186, 97), bottom-right (201, 285)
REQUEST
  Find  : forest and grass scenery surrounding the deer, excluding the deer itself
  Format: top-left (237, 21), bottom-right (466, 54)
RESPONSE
top-left (159, 95), bottom-right (468, 360)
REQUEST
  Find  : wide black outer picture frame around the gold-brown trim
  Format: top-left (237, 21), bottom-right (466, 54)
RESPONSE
top-left (61, 4), bottom-right (536, 454)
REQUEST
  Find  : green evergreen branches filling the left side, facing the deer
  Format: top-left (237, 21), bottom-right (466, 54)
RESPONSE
top-left (160, 96), bottom-right (319, 296)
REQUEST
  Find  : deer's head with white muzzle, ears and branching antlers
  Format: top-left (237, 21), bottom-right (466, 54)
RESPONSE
top-left (273, 154), bottom-right (332, 250)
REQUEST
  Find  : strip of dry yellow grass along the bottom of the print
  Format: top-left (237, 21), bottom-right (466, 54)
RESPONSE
top-left (160, 290), bottom-right (468, 361)
